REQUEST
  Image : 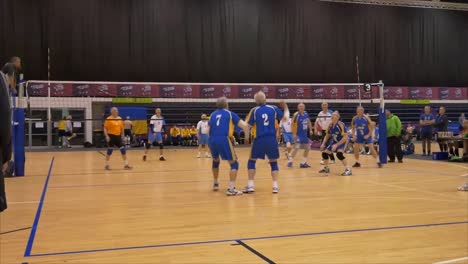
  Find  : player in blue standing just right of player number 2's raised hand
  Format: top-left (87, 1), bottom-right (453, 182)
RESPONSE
top-left (288, 103), bottom-right (313, 168)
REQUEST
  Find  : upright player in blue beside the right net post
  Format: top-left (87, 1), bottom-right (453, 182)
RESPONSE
top-left (351, 106), bottom-right (382, 168)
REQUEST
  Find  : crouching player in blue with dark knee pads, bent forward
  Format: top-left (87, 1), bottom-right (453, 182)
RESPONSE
top-left (319, 112), bottom-right (353, 176)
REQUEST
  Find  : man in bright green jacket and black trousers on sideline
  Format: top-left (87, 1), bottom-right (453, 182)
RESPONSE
top-left (385, 109), bottom-right (403, 163)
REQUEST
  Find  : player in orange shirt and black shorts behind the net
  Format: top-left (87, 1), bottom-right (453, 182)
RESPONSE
top-left (104, 107), bottom-right (132, 170)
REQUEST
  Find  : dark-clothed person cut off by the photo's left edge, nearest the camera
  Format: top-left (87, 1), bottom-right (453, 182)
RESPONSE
top-left (0, 69), bottom-right (12, 212)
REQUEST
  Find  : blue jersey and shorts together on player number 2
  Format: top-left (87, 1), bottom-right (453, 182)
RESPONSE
top-left (247, 105), bottom-right (284, 159)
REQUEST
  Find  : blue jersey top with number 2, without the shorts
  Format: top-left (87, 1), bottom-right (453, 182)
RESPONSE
top-left (247, 104), bottom-right (284, 138)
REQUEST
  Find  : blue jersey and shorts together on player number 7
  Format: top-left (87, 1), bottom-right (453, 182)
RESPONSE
top-left (208, 109), bottom-right (241, 160)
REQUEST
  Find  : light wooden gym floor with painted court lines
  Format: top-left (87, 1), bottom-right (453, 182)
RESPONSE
top-left (0, 145), bottom-right (468, 264)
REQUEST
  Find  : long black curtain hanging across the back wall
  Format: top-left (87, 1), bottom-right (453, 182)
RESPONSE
top-left (0, 0), bottom-right (468, 86)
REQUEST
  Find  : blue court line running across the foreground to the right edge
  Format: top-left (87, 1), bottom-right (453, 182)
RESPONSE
top-left (25, 221), bottom-right (468, 257)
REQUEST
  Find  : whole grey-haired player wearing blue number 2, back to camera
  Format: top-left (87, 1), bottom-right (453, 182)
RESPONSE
top-left (243, 91), bottom-right (289, 193)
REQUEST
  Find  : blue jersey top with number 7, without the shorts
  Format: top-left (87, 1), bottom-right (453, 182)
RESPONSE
top-left (208, 109), bottom-right (241, 137)
